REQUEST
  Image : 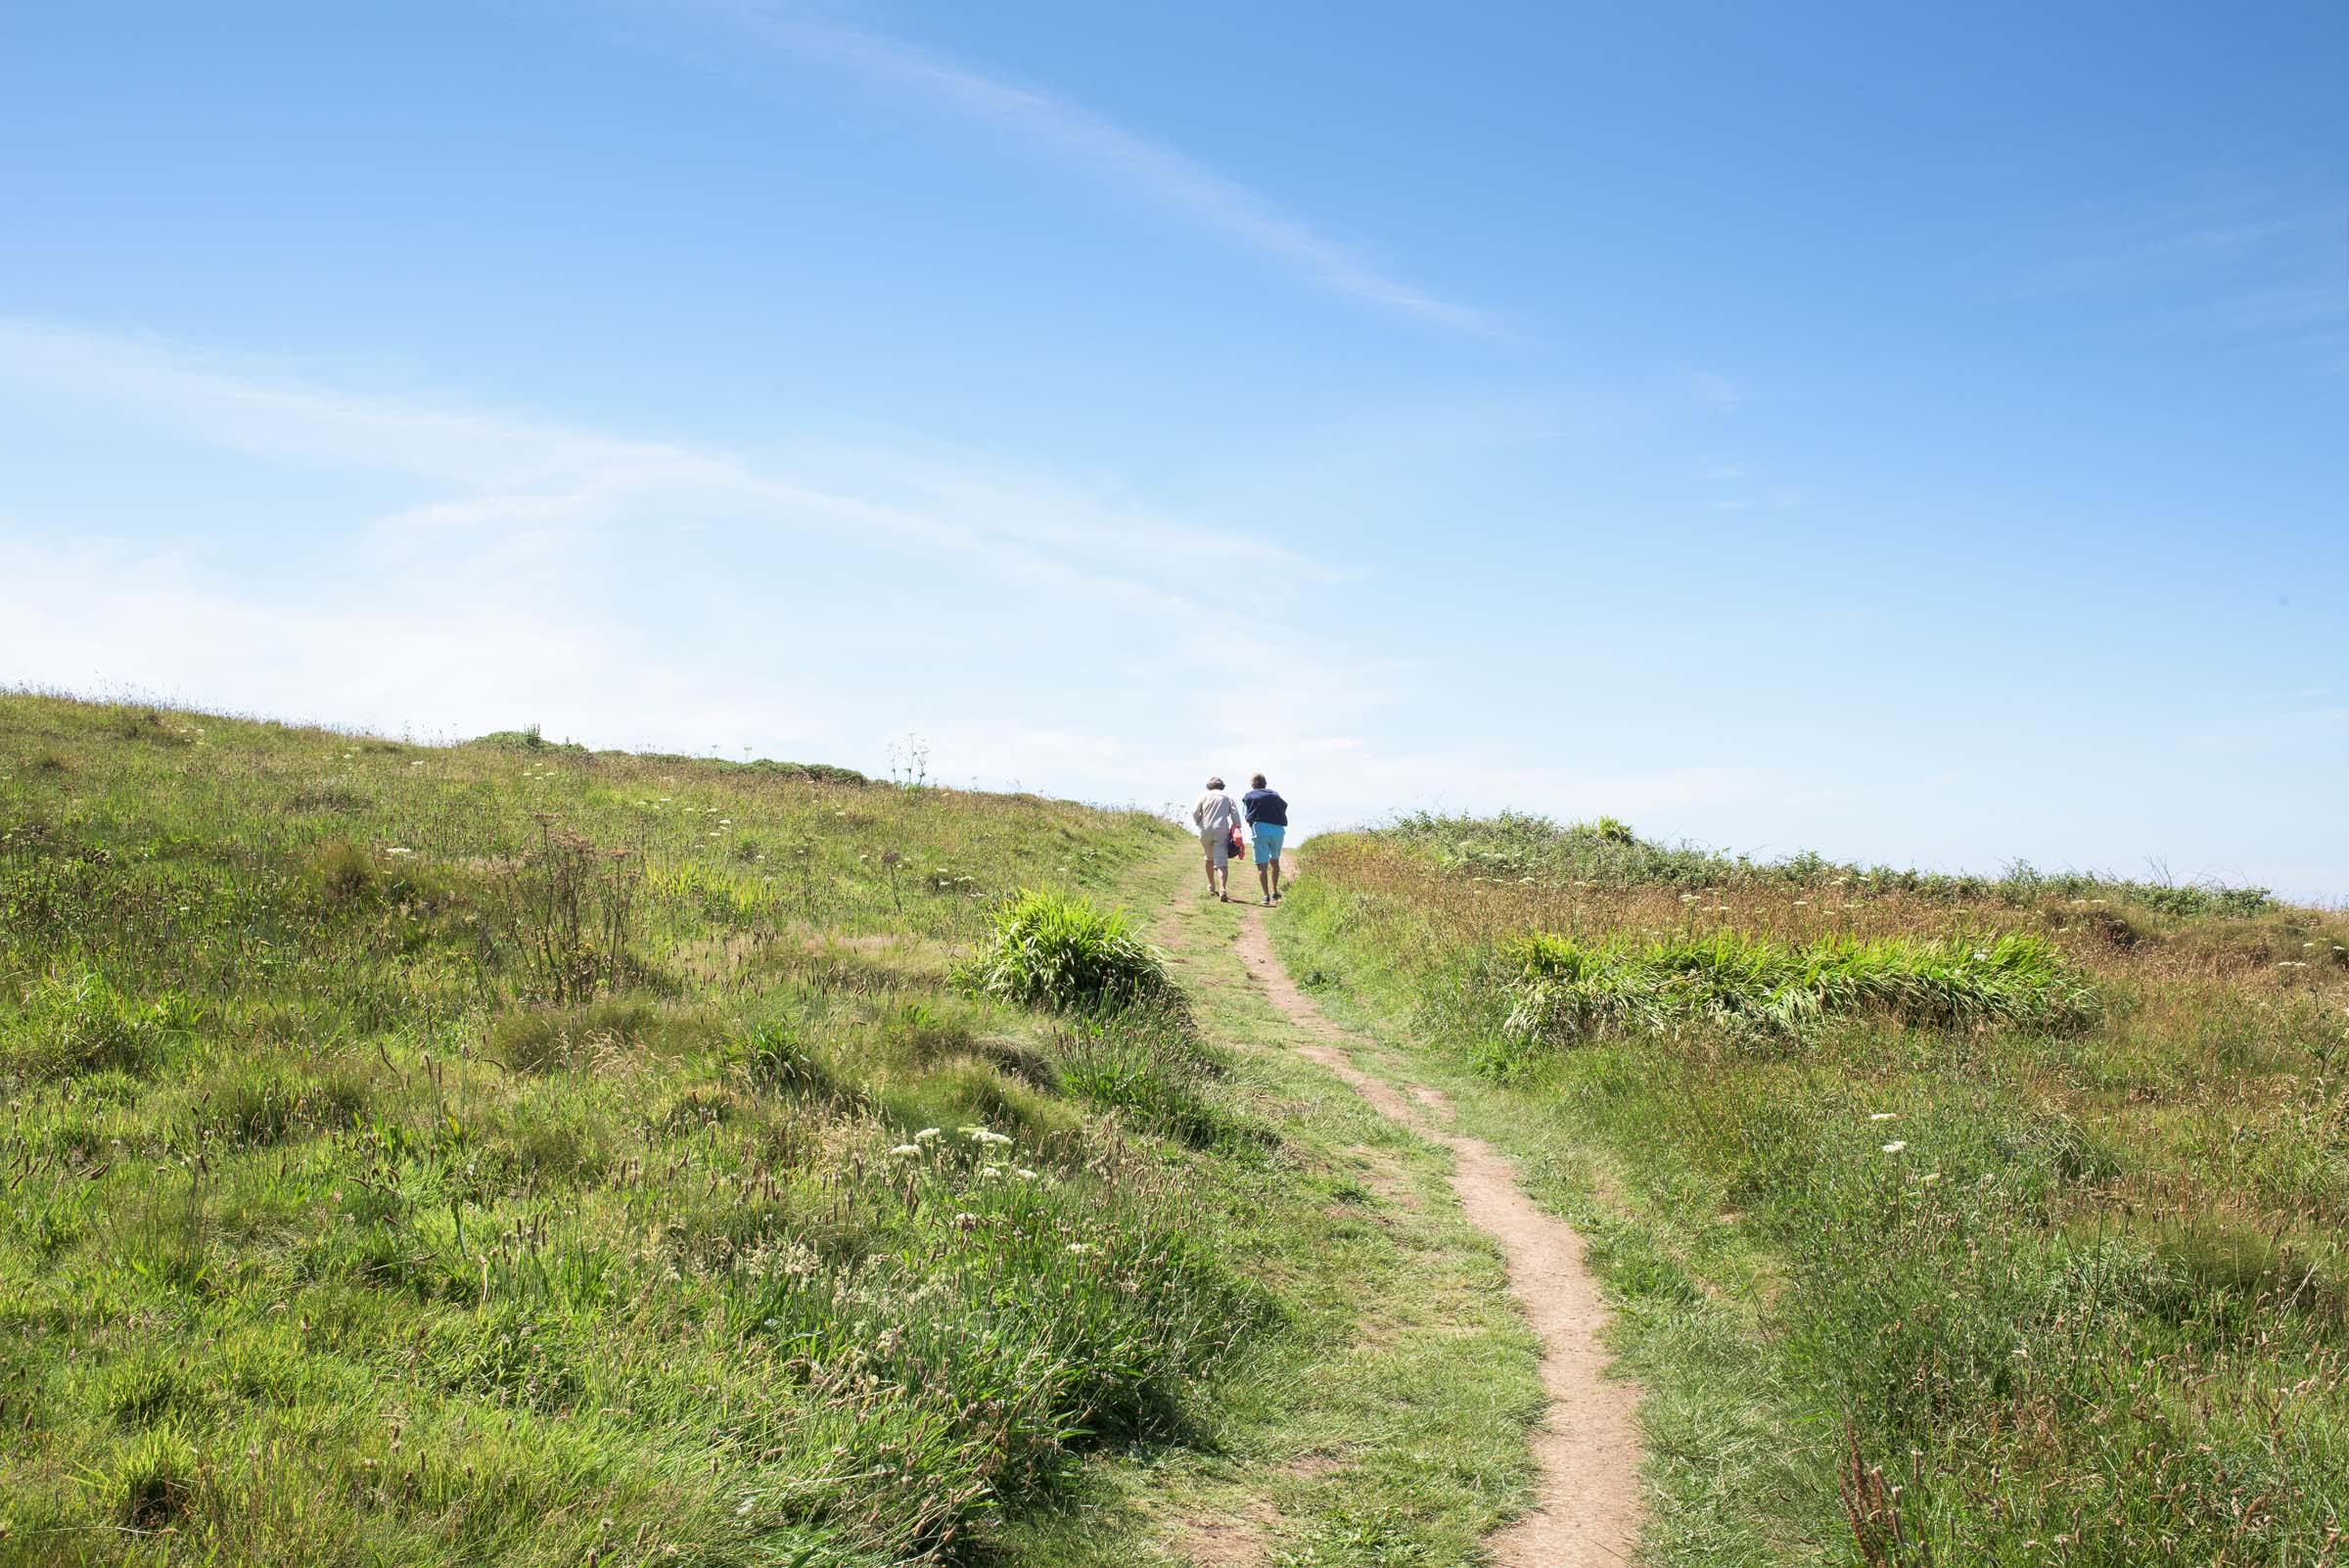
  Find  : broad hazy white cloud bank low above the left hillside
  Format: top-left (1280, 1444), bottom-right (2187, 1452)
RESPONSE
top-left (0, 322), bottom-right (1409, 796)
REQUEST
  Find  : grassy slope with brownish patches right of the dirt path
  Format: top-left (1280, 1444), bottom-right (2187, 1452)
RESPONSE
top-left (1282, 817), bottom-right (2349, 1566)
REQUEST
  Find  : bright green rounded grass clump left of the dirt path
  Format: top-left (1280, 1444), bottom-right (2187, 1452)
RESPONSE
top-left (956, 888), bottom-right (1176, 1012)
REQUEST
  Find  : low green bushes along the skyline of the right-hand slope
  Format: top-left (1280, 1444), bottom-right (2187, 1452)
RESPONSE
top-left (1388, 812), bottom-right (2274, 915)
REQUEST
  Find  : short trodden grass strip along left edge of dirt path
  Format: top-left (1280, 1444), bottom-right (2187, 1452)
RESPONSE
top-left (1012, 877), bottom-right (1543, 1568)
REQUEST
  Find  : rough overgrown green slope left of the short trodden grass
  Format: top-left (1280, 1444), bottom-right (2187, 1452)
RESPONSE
top-left (0, 695), bottom-right (1268, 1568)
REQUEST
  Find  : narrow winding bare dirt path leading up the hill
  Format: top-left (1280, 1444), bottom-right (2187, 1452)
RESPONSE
top-left (1240, 906), bottom-right (1639, 1568)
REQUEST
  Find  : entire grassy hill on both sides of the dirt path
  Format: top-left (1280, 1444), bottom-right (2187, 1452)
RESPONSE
top-left (14, 695), bottom-right (2349, 1568)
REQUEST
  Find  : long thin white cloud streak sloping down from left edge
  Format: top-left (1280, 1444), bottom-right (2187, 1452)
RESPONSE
top-left (0, 319), bottom-right (1339, 618)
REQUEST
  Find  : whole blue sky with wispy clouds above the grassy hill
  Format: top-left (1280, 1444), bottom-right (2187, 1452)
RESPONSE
top-left (0, 0), bottom-right (2349, 899)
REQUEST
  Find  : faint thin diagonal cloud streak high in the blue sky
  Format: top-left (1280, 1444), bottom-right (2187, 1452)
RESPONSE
top-left (671, 5), bottom-right (1508, 338)
